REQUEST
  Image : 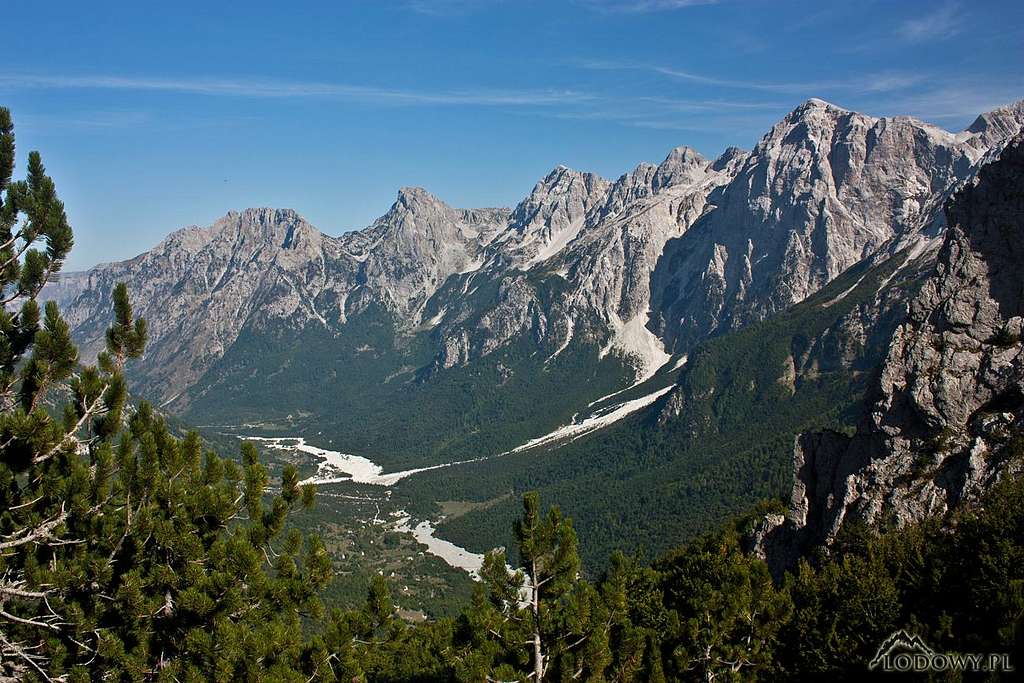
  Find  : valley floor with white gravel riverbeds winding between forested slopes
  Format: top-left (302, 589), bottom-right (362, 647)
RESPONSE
top-left (208, 376), bottom-right (685, 618)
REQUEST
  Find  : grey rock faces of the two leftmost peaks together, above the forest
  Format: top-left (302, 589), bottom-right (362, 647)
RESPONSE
top-left (51, 193), bottom-right (508, 409)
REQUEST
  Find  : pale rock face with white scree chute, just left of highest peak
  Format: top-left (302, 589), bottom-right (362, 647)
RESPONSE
top-left (439, 147), bottom-right (743, 377)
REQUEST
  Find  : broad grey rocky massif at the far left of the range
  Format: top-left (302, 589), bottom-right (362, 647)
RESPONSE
top-left (57, 209), bottom-right (339, 398)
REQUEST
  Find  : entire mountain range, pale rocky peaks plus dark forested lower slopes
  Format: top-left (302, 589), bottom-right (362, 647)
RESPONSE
top-left (44, 99), bottom-right (1024, 557)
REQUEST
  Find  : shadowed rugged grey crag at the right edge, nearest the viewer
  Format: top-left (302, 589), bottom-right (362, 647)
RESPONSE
top-left (759, 136), bottom-right (1024, 569)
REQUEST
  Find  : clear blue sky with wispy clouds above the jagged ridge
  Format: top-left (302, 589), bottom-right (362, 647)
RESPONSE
top-left (0, 0), bottom-right (1024, 268)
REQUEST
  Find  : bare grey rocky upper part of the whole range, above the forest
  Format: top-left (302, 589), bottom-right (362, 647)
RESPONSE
top-left (50, 99), bottom-right (1024, 440)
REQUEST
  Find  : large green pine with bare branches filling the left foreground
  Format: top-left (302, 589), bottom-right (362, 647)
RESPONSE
top-left (0, 109), bottom-right (331, 681)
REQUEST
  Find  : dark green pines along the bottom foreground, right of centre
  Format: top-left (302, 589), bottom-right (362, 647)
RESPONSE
top-left (319, 476), bottom-right (1024, 683)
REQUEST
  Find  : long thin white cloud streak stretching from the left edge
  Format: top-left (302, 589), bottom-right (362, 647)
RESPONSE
top-left (0, 74), bottom-right (591, 106)
